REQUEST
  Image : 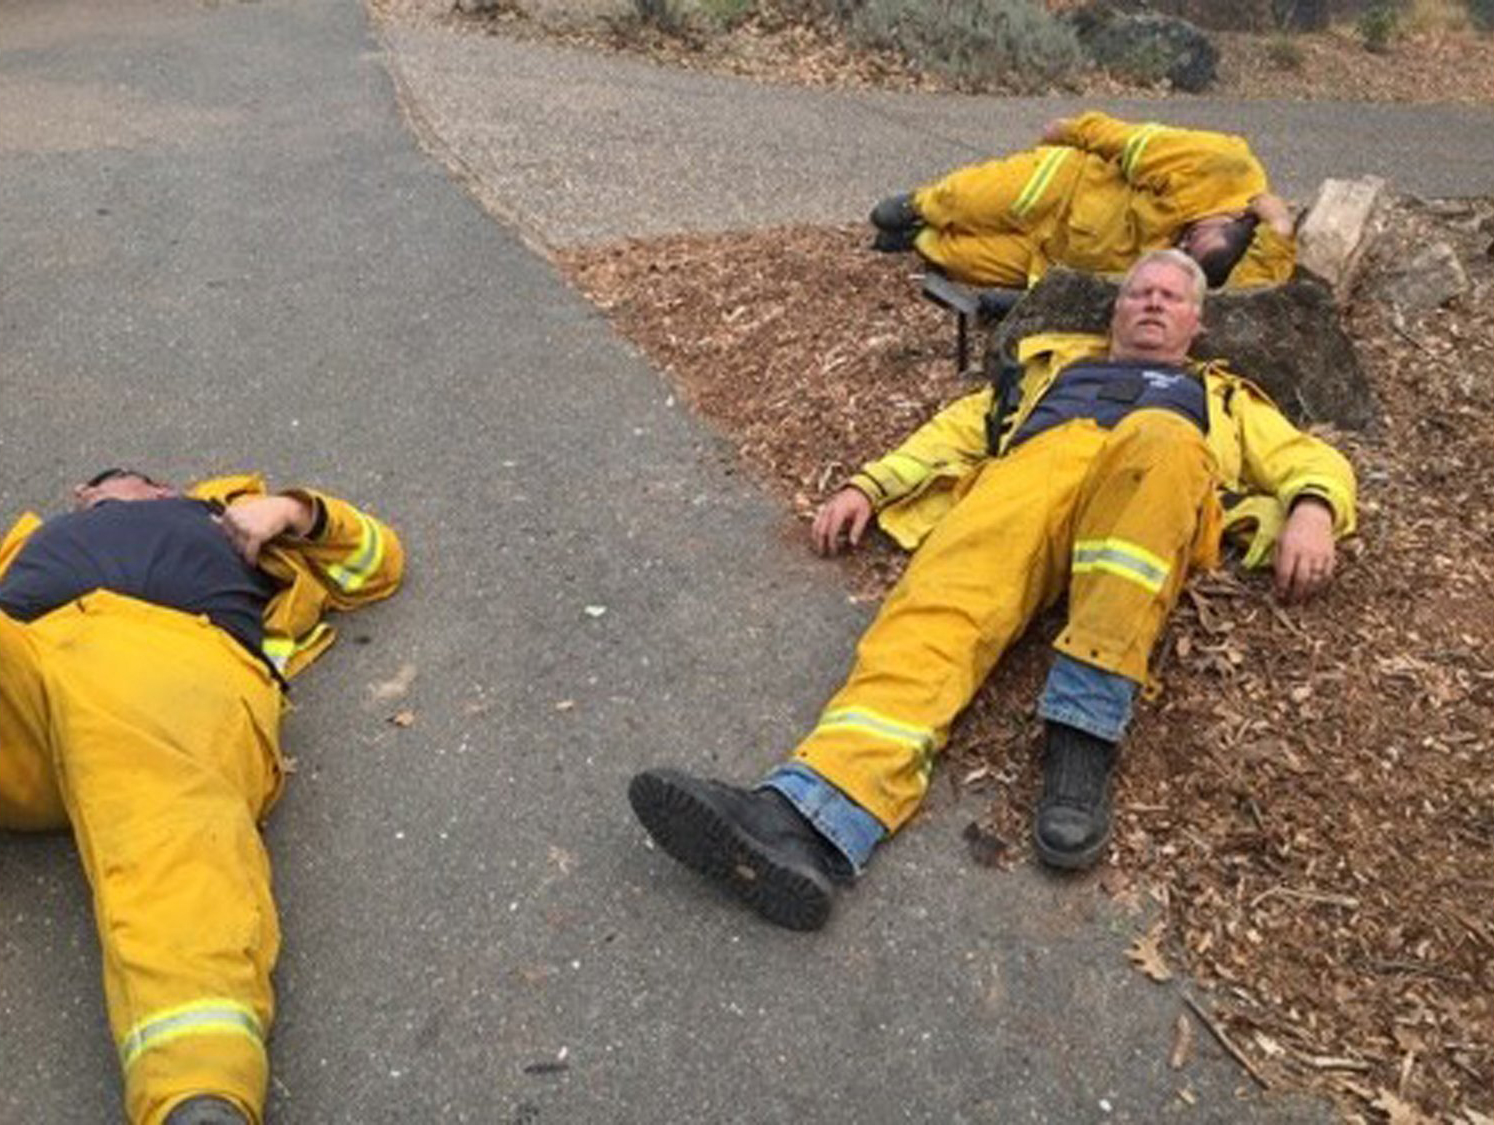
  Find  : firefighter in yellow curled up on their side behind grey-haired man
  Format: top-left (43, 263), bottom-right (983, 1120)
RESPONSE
top-left (871, 112), bottom-right (1297, 288)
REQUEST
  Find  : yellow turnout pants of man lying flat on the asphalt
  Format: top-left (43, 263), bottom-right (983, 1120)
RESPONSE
top-left (0, 592), bottom-right (282, 1125)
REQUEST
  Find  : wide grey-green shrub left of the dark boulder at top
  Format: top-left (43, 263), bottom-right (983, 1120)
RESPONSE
top-left (850, 0), bottom-right (1083, 90)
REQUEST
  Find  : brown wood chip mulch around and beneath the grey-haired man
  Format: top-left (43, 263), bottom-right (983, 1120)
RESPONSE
top-left (560, 200), bottom-right (1494, 1125)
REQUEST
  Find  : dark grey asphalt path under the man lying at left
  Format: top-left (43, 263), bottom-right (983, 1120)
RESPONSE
top-left (0, 0), bottom-right (1488, 1125)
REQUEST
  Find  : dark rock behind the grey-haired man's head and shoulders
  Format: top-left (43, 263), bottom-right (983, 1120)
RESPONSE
top-left (986, 269), bottom-right (1374, 430)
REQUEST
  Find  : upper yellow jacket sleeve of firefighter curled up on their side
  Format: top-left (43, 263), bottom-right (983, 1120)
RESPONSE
top-left (1059, 111), bottom-right (1267, 223)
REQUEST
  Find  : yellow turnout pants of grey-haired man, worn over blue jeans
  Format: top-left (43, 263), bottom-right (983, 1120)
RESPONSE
top-left (793, 409), bottom-right (1218, 832)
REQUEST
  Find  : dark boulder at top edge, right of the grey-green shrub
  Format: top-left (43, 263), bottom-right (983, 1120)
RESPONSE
top-left (1070, 1), bottom-right (1219, 94)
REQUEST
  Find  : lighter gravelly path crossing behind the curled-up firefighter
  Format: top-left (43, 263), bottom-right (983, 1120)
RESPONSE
top-left (384, 25), bottom-right (1494, 247)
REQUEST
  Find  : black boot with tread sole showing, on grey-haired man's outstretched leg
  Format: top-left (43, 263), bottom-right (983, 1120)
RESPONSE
top-left (627, 769), bottom-right (850, 929)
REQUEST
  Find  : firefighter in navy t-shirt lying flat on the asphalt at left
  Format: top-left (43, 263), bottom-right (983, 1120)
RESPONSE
top-left (0, 469), bottom-right (403, 1125)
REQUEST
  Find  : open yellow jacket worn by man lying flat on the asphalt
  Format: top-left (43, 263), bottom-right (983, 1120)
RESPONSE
top-left (0, 474), bottom-right (405, 680)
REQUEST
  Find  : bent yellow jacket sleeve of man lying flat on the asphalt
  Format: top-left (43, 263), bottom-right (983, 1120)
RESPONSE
top-left (279, 489), bottom-right (405, 610)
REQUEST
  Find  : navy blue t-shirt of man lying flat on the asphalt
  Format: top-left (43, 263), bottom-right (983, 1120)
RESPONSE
top-left (0, 496), bottom-right (276, 656)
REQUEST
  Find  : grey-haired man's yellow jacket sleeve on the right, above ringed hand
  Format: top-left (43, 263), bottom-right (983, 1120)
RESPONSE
top-left (1234, 384), bottom-right (1357, 536)
